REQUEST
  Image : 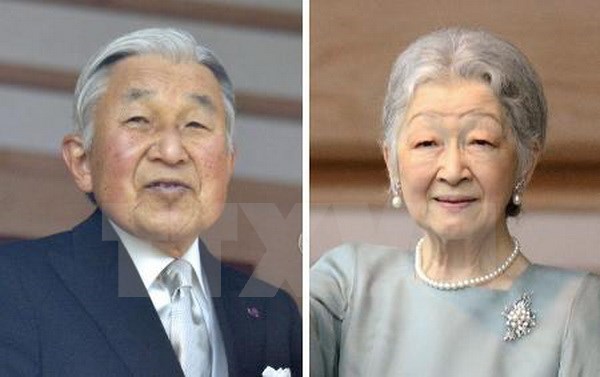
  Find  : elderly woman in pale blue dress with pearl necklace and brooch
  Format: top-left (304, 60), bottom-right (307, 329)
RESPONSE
top-left (310, 29), bottom-right (600, 377)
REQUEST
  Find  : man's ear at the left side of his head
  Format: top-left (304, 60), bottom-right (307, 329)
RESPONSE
top-left (62, 134), bottom-right (93, 193)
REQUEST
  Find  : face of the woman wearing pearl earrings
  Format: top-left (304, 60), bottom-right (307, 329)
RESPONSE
top-left (397, 78), bottom-right (518, 241)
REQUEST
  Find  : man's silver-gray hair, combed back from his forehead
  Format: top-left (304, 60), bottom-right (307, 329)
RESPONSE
top-left (73, 28), bottom-right (235, 150)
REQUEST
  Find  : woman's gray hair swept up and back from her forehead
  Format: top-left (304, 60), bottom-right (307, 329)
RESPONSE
top-left (383, 28), bottom-right (547, 216)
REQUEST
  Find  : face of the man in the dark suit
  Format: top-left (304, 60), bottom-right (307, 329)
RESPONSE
top-left (72, 55), bottom-right (234, 256)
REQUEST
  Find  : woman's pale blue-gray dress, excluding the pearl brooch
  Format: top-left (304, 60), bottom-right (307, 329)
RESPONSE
top-left (310, 244), bottom-right (600, 377)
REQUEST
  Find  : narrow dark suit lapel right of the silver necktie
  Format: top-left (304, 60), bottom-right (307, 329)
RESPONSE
top-left (198, 240), bottom-right (240, 377)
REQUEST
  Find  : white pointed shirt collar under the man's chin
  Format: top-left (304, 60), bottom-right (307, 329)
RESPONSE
top-left (108, 219), bottom-right (202, 289)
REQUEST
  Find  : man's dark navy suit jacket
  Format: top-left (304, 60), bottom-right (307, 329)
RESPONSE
top-left (0, 211), bottom-right (302, 377)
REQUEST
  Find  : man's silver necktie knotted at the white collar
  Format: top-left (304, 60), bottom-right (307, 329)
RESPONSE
top-left (161, 259), bottom-right (212, 377)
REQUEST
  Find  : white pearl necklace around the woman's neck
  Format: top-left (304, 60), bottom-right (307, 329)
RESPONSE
top-left (415, 238), bottom-right (521, 291)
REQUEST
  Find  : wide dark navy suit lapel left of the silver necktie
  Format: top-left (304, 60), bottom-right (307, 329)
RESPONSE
top-left (49, 211), bottom-right (183, 377)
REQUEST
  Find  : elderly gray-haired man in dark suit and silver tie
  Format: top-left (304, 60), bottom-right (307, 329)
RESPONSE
top-left (0, 29), bottom-right (301, 377)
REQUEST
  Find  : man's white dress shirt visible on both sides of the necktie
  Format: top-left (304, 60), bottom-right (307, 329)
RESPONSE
top-left (109, 220), bottom-right (228, 377)
